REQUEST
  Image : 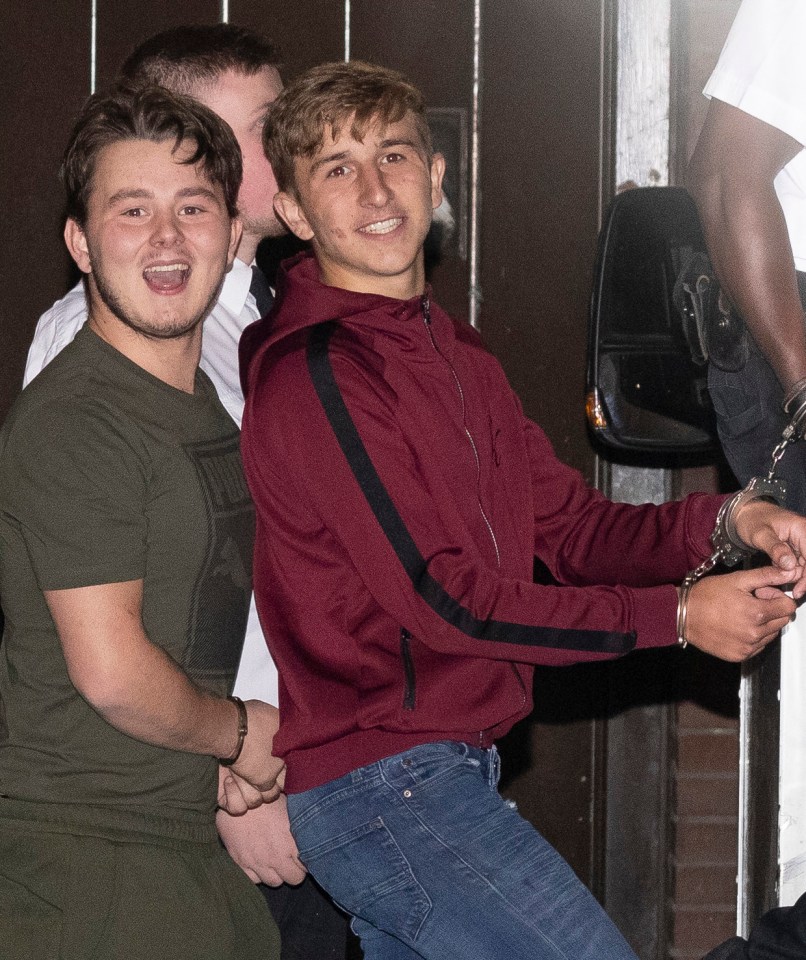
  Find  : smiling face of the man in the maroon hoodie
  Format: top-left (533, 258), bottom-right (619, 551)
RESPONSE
top-left (275, 113), bottom-right (445, 299)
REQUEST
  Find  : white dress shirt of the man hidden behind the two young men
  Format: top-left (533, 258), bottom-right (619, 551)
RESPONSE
top-left (23, 259), bottom-right (277, 705)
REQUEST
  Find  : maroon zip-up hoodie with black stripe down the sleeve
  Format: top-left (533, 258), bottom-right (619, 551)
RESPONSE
top-left (241, 254), bottom-right (723, 793)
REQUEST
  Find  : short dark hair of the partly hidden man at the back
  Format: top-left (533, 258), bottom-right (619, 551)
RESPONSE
top-left (119, 23), bottom-right (279, 95)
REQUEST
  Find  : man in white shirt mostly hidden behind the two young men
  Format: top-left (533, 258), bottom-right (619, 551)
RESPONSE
top-left (24, 23), bottom-right (347, 960)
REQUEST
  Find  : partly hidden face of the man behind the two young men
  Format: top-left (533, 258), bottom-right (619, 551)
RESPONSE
top-left (193, 67), bottom-right (283, 263)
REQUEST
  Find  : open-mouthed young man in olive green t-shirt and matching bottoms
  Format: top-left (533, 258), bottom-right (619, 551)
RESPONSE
top-left (0, 88), bottom-right (282, 960)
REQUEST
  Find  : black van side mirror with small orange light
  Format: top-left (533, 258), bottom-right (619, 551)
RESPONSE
top-left (585, 187), bottom-right (719, 454)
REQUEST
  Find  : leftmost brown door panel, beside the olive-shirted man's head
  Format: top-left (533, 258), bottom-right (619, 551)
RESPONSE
top-left (0, 0), bottom-right (90, 420)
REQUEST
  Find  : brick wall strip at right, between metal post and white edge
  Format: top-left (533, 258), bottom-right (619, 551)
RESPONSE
top-left (668, 0), bottom-right (740, 960)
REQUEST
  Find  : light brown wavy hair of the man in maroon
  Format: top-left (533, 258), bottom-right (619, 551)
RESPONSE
top-left (263, 60), bottom-right (432, 192)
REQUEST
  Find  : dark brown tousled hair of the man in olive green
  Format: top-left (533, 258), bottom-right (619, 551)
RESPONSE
top-left (61, 85), bottom-right (243, 226)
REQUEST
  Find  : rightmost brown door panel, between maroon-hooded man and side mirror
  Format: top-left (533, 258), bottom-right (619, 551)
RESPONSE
top-left (481, 0), bottom-right (607, 888)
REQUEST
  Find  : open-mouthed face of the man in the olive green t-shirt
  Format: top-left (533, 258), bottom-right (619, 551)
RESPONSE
top-left (65, 140), bottom-right (240, 340)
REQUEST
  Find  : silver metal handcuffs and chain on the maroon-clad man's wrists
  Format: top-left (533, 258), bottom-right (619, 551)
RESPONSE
top-left (676, 417), bottom-right (802, 647)
